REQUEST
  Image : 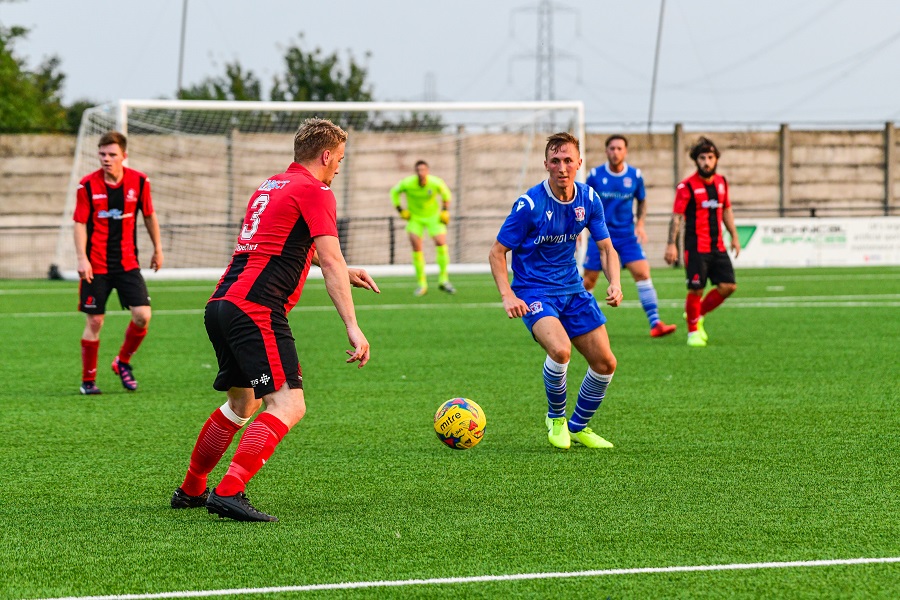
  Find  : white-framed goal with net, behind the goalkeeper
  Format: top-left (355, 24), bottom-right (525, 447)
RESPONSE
top-left (56, 100), bottom-right (584, 279)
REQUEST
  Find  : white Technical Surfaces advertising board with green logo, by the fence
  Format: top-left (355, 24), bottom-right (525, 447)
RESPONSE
top-left (734, 217), bottom-right (900, 267)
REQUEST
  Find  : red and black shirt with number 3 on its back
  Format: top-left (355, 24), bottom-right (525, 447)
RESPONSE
top-left (210, 163), bottom-right (337, 313)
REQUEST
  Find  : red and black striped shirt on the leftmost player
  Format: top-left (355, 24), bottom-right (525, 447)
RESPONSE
top-left (73, 167), bottom-right (153, 275)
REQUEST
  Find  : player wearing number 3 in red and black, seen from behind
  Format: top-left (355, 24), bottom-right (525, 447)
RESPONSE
top-left (171, 119), bottom-right (379, 521)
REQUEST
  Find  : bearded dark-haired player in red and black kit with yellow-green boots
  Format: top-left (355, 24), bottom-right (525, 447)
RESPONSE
top-left (665, 137), bottom-right (741, 347)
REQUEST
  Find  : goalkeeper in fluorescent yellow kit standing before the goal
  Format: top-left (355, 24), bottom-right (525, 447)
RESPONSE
top-left (391, 160), bottom-right (456, 296)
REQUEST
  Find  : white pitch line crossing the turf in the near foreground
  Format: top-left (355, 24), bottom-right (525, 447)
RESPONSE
top-left (28, 556), bottom-right (900, 600)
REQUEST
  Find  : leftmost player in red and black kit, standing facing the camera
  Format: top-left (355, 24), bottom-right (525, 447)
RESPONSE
top-left (74, 131), bottom-right (163, 395)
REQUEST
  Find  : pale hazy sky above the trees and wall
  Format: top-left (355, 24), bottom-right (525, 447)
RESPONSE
top-left (0, 0), bottom-right (900, 128)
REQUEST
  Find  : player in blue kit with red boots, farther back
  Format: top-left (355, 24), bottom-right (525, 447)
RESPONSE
top-left (584, 135), bottom-right (677, 337)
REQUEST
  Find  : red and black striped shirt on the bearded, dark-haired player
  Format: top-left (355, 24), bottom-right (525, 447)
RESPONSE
top-left (673, 173), bottom-right (731, 254)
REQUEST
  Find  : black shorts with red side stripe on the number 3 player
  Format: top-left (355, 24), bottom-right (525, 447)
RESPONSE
top-left (204, 300), bottom-right (303, 398)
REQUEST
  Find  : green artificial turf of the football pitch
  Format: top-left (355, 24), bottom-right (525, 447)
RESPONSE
top-left (0, 268), bottom-right (900, 598)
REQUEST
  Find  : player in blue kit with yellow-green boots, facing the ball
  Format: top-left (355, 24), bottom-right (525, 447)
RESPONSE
top-left (489, 133), bottom-right (622, 448)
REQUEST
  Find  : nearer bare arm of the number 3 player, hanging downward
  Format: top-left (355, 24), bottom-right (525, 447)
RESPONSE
top-left (315, 235), bottom-right (369, 368)
